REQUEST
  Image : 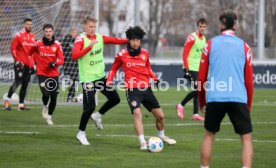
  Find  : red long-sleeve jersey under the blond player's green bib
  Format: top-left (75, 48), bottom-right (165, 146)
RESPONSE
top-left (72, 34), bottom-right (128, 60)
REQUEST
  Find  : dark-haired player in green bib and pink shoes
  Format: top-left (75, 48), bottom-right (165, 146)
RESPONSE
top-left (176, 18), bottom-right (207, 121)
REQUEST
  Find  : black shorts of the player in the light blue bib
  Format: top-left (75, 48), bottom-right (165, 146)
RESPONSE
top-left (204, 102), bottom-right (252, 135)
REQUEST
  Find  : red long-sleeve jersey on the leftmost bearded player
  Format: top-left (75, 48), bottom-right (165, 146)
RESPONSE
top-left (10, 30), bottom-right (36, 68)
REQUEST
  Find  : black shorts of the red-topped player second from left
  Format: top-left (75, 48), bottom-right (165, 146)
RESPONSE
top-left (37, 75), bottom-right (59, 95)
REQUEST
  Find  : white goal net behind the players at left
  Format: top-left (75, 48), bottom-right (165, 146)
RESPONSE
top-left (0, 0), bottom-right (98, 103)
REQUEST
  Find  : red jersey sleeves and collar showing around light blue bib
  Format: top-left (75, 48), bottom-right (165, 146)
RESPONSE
top-left (198, 31), bottom-right (254, 111)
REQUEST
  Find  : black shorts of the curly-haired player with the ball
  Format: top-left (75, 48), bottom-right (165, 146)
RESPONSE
top-left (126, 87), bottom-right (160, 114)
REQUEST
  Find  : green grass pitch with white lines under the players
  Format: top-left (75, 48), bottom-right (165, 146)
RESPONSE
top-left (0, 88), bottom-right (276, 168)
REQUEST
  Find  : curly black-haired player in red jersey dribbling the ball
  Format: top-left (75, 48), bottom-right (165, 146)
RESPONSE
top-left (107, 26), bottom-right (176, 150)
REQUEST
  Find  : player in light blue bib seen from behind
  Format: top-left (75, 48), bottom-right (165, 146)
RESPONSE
top-left (198, 11), bottom-right (253, 168)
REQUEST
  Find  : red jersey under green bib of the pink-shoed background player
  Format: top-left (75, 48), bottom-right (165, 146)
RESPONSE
top-left (182, 32), bottom-right (203, 69)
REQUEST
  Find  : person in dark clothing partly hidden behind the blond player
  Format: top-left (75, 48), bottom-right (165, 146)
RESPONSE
top-left (62, 28), bottom-right (78, 102)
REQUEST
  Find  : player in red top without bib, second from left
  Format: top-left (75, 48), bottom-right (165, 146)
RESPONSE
top-left (29, 24), bottom-right (64, 125)
